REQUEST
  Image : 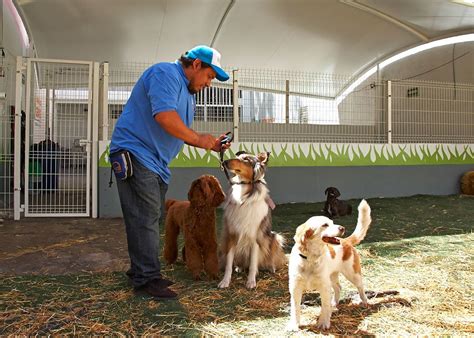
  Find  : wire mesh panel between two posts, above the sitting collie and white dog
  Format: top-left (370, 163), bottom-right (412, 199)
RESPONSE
top-left (238, 70), bottom-right (385, 143)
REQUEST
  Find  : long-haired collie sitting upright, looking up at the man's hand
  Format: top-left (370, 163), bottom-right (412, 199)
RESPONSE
top-left (219, 152), bottom-right (286, 289)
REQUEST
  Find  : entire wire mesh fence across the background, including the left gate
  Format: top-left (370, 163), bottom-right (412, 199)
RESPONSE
top-left (0, 58), bottom-right (474, 218)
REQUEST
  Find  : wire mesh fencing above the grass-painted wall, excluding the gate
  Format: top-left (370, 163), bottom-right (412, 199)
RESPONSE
top-left (104, 63), bottom-right (474, 143)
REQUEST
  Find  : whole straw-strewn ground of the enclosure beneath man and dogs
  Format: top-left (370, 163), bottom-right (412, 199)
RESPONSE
top-left (0, 195), bottom-right (474, 336)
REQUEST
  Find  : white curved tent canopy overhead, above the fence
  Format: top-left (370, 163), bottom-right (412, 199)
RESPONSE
top-left (16, 0), bottom-right (474, 75)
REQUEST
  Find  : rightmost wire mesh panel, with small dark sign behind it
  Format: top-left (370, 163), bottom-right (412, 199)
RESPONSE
top-left (392, 80), bottom-right (474, 143)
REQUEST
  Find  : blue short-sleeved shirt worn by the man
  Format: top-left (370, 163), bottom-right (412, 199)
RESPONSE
top-left (110, 61), bottom-right (195, 184)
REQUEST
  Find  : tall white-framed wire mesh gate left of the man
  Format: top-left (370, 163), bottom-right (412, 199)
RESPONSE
top-left (25, 59), bottom-right (92, 216)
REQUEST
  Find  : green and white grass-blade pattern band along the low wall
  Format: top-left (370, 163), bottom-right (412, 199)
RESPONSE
top-left (99, 141), bottom-right (474, 168)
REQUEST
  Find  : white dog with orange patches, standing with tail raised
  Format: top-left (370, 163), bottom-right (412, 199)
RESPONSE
top-left (287, 200), bottom-right (372, 331)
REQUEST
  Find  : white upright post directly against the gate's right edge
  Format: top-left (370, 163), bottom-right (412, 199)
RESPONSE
top-left (91, 62), bottom-right (100, 218)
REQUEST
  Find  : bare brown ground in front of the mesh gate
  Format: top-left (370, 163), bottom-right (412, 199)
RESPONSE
top-left (0, 218), bottom-right (129, 275)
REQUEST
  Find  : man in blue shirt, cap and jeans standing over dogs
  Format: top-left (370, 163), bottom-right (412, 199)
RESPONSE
top-left (110, 46), bottom-right (230, 299)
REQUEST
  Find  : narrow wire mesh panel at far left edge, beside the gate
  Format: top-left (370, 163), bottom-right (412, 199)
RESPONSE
top-left (0, 56), bottom-right (15, 218)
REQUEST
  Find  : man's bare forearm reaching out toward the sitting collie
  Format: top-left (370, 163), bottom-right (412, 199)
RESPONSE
top-left (155, 110), bottom-right (223, 151)
